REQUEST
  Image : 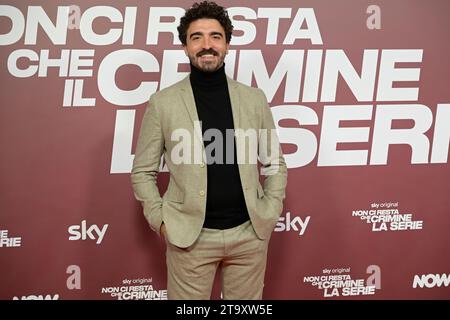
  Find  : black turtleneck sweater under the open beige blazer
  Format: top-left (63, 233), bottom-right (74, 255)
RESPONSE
top-left (190, 64), bottom-right (249, 229)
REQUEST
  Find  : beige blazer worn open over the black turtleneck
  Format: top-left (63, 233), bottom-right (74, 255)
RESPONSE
top-left (131, 77), bottom-right (287, 248)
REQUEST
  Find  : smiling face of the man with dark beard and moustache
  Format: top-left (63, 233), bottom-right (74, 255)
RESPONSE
top-left (184, 19), bottom-right (229, 72)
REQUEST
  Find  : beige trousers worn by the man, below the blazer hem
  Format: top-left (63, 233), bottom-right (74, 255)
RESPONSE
top-left (166, 221), bottom-right (269, 300)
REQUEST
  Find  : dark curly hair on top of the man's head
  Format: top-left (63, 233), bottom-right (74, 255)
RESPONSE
top-left (177, 1), bottom-right (233, 45)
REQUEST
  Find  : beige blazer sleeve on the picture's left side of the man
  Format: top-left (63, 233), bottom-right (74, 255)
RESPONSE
top-left (131, 95), bottom-right (164, 235)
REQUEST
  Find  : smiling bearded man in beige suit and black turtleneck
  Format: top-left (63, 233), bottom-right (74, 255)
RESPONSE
top-left (131, 1), bottom-right (287, 299)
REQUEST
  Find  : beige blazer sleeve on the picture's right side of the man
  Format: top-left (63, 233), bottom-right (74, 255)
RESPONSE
top-left (258, 89), bottom-right (287, 216)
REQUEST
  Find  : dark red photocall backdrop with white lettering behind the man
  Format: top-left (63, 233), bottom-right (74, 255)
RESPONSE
top-left (0, 0), bottom-right (450, 300)
